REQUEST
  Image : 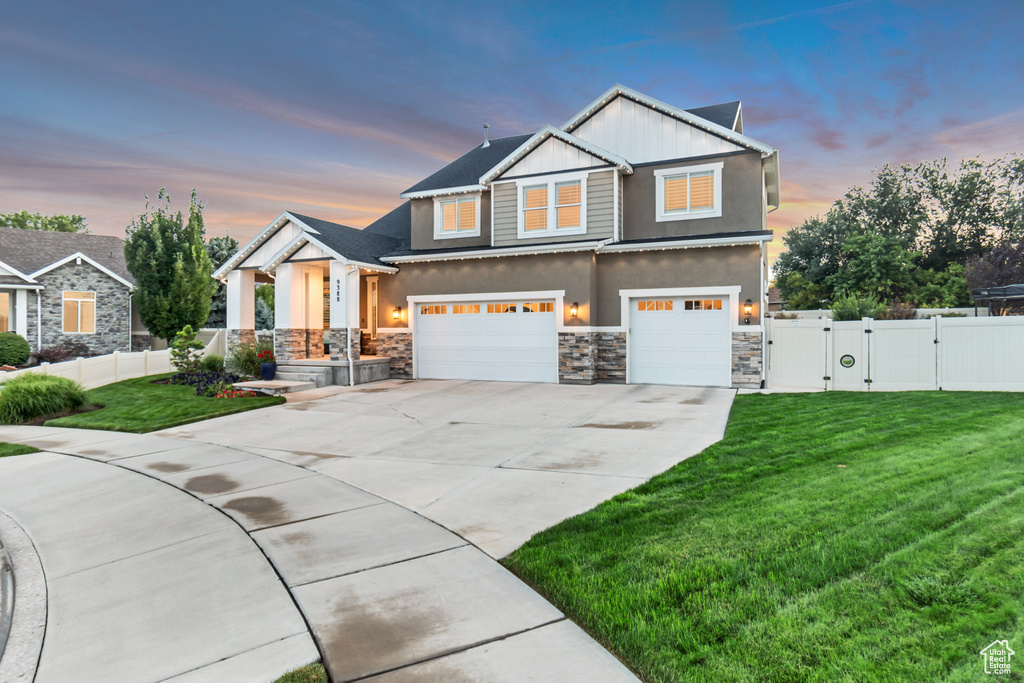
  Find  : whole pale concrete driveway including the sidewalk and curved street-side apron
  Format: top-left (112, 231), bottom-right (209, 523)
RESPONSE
top-left (0, 381), bottom-right (733, 683)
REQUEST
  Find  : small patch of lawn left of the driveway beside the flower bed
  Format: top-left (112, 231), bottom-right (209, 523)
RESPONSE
top-left (46, 375), bottom-right (285, 434)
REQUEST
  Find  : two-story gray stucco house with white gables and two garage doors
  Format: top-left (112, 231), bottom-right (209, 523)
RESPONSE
top-left (215, 86), bottom-right (779, 386)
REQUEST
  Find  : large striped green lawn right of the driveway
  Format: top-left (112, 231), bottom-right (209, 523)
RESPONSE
top-left (506, 392), bottom-right (1024, 682)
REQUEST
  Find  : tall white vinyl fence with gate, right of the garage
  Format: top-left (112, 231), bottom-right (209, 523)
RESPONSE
top-left (766, 316), bottom-right (1024, 391)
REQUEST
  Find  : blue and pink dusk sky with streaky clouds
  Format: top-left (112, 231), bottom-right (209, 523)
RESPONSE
top-left (0, 0), bottom-right (1024, 262)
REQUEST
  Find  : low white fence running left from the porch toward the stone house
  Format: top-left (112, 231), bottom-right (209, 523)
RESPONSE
top-left (0, 331), bottom-right (224, 389)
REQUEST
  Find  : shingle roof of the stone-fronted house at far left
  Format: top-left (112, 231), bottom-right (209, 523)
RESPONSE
top-left (0, 227), bottom-right (135, 283)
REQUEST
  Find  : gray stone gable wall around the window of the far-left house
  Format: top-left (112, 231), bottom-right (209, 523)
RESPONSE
top-left (34, 261), bottom-right (132, 355)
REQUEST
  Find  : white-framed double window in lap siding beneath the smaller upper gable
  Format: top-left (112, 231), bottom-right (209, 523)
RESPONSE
top-left (516, 173), bottom-right (588, 240)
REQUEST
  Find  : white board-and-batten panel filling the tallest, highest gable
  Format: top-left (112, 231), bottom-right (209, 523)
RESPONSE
top-left (572, 95), bottom-right (744, 164)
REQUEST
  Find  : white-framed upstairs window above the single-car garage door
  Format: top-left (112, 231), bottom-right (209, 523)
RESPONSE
top-left (654, 162), bottom-right (723, 222)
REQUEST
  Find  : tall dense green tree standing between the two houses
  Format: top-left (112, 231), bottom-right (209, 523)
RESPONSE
top-left (125, 189), bottom-right (216, 339)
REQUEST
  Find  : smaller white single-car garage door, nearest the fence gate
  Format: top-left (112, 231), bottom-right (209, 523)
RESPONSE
top-left (630, 296), bottom-right (732, 386)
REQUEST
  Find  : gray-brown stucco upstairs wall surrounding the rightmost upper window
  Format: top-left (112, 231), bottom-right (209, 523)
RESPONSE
top-left (623, 152), bottom-right (766, 240)
